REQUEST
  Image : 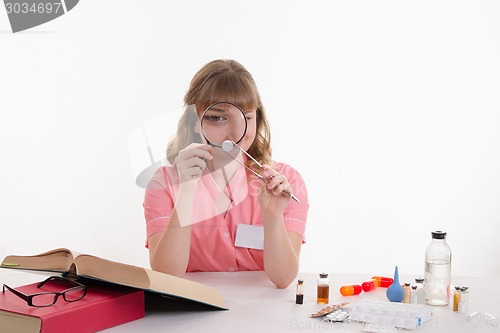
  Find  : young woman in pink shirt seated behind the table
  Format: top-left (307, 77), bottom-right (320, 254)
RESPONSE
top-left (144, 60), bottom-right (309, 288)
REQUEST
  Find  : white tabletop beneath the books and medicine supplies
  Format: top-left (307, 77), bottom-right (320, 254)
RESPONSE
top-left (0, 269), bottom-right (500, 333)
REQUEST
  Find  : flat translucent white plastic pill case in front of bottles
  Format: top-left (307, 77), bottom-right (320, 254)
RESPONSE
top-left (350, 300), bottom-right (432, 330)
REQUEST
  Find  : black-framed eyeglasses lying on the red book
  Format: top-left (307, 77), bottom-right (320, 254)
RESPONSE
top-left (3, 276), bottom-right (87, 308)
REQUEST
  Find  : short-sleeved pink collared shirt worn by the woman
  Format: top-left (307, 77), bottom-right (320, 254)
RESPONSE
top-left (143, 163), bottom-right (309, 272)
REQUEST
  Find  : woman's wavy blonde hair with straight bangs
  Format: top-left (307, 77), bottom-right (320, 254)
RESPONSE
top-left (167, 60), bottom-right (272, 165)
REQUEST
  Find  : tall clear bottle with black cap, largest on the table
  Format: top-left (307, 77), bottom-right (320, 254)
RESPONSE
top-left (424, 231), bottom-right (451, 305)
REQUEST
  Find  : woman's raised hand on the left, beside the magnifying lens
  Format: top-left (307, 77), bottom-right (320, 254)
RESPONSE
top-left (175, 143), bottom-right (212, 184)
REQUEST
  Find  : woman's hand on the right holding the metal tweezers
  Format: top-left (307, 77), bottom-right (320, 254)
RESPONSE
top-left (258, 164), bottom-right (292, 217)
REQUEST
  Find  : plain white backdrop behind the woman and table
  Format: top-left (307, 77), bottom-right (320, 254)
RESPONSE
top-left (0, 0), bottom-right (500, 282)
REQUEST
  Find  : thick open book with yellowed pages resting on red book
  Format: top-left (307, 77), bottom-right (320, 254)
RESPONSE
top-left (0, 248), bottom-right (226, 309)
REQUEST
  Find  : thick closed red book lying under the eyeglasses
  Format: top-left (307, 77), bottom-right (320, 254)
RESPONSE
top-left (0, 282), bottom-right (145, 333)
